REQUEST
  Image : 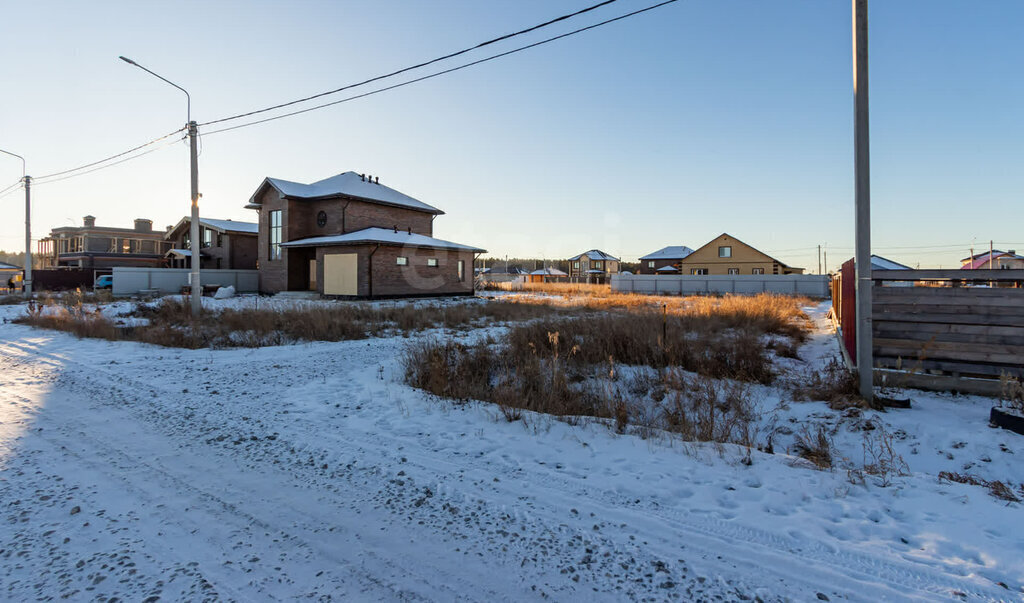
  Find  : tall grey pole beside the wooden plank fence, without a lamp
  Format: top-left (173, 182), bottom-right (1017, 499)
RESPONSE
top-left (853, 0), bottom-right (874, 401)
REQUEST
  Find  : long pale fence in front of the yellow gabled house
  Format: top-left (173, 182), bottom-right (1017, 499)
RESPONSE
top-left (611, 274), bottom-right (828, 298)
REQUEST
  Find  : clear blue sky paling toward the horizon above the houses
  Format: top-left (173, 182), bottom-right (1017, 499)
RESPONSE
top-left (0, 0), bottom-right (1024, 270)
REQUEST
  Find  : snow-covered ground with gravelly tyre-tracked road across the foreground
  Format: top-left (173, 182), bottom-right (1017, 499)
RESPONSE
top-left (0, 298), bottom-right (1024, 601)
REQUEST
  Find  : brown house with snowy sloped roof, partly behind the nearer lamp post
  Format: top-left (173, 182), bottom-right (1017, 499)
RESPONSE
top-left (164, 217), bottom-right (259, 270)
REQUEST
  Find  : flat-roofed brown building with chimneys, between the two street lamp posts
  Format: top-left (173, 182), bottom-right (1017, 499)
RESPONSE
top-left (36, 216), bottom-right (169, 270)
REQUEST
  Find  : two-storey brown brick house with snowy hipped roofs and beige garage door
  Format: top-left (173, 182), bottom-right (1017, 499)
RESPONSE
top-left (246, 172), bottom-right (484, 298)
